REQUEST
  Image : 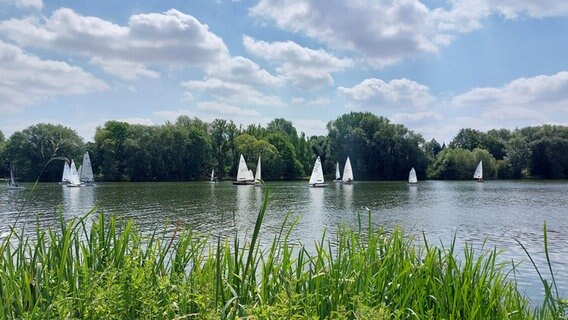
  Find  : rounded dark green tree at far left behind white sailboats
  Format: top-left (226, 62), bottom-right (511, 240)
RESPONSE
top-left (5, 123), bottom-right (85, 181)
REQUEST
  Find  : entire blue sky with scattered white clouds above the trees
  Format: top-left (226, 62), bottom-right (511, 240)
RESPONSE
top-left (0, 0), bottom-right (568, 143)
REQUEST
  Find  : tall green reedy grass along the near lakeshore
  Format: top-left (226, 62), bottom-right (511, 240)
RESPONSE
top-left (0, 189), bottom-right (567, 319)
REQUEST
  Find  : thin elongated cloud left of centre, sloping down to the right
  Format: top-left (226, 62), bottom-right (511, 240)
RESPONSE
top-left (182, 79), bottom-right (284, 107)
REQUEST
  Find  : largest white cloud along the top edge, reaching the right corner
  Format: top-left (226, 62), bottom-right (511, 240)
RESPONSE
top-left (249, 0), bottom-right (568, 68)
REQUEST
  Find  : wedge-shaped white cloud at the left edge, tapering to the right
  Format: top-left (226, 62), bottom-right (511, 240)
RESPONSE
top-left (0, 41), bottom-right (109, 112)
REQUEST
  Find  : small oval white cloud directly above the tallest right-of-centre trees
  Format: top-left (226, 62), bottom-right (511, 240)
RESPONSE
top-left (337, 78), bottom-right (434, 109)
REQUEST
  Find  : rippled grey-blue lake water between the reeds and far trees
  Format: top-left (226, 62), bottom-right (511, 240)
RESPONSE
top-left (0, 181), bottom-right (568, 302)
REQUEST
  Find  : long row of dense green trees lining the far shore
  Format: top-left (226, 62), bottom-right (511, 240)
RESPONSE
top-left (0, 112), bottom-right (568, 181)
